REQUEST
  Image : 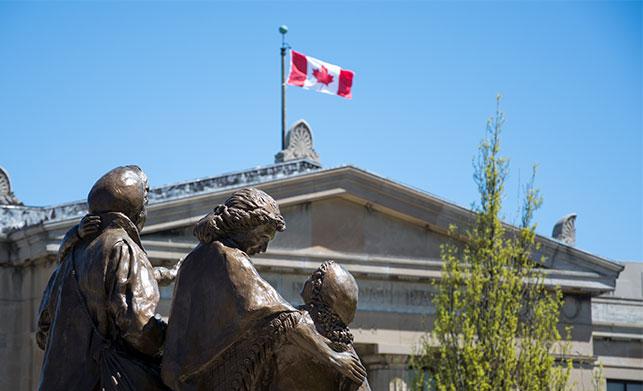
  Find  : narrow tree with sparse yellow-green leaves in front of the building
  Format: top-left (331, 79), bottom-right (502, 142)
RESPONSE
top-left (412, 96), bottom-right (572, 391)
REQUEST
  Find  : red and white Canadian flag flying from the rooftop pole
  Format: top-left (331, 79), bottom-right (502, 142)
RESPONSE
top-left (288, 50), bottom-right (355, 99)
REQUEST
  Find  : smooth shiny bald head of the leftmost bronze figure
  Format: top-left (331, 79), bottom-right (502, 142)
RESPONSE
top-left (87, 166), bottom-right (149, 231)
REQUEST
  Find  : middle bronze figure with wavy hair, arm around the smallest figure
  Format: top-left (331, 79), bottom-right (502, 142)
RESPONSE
top-left (161, 189), bottom-right (366, 391)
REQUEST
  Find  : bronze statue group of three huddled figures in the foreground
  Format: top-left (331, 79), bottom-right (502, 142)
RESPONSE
top-left (36, 166), bottom-right (370, 391)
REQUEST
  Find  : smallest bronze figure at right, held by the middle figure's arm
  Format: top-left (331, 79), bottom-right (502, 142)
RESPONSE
top-left (271, 261), bottom-right (371, 391)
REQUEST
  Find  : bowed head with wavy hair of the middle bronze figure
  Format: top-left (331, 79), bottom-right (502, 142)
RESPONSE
top-left (194, 188), bottom-right (286, 255)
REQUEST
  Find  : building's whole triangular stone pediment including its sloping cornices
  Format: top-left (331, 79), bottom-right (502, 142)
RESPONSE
top-left (18, 166), bottom-right (622, 293)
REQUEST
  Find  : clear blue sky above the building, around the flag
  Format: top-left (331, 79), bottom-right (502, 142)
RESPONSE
top-left (0, 1), bottom-right (643, 260)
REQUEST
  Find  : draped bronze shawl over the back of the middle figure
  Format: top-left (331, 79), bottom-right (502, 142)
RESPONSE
top-left (161, 241), bottom-right (301, 391)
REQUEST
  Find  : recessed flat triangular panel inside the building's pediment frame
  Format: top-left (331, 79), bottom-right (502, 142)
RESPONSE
top-left (142, 191), bottom-right (447, 263)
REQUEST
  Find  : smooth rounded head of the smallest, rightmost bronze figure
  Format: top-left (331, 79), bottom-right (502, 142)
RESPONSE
top-left (301, 261), bottom-right (359, 326)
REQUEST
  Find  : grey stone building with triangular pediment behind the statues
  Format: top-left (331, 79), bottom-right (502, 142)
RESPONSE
top-left (0, 121), bottom-right (643, 391)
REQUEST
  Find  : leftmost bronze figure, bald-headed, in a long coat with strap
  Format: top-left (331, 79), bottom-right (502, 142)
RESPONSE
top-left (37, 166), bottom-right (166, 391)
